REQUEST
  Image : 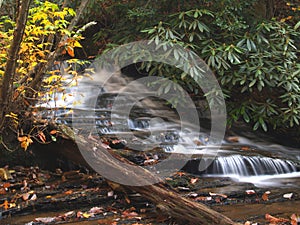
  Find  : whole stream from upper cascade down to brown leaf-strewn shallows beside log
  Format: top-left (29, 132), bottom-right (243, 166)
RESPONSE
top-left (8, 60), bottom-right (300, 224)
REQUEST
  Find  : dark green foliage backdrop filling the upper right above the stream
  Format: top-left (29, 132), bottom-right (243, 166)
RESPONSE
top-left (74, 0), bottom-right (300, 130)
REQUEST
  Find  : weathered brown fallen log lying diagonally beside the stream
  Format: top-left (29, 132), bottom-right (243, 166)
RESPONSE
top-left (58, 125), bottom-right (235, 225)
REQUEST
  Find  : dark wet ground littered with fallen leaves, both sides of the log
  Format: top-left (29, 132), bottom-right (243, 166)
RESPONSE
top-left (0, 163), bottom-right (300, 225)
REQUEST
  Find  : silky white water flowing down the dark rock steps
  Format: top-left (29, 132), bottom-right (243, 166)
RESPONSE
top-left (39, 61), bottom-right (300, 186)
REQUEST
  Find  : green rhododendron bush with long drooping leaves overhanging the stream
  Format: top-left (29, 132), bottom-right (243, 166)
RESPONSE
top-left (143, 1), bottom-right (300, 131)
